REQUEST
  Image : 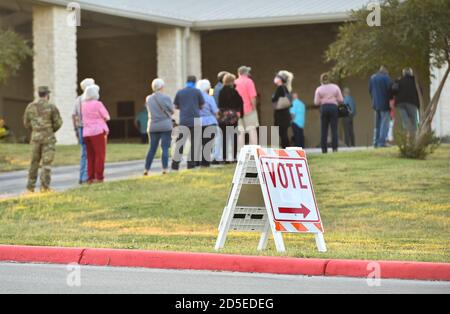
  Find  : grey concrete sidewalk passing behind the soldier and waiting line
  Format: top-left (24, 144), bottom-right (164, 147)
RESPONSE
top-left (0, 147), bottom-right (368, 199)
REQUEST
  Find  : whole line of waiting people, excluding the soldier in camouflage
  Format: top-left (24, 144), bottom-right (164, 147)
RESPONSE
top-left (73, 66), bottom-right (419, 183)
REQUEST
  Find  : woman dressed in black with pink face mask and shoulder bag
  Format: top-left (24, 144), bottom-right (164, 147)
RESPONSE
top-left (272, 71), bottom-right (294, 149)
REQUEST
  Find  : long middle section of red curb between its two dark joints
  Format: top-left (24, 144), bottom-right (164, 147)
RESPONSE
top-left (80, 249), bottom-right (327, 276)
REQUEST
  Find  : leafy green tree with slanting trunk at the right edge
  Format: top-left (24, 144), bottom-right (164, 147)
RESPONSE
top-left (326, 0), bottom-right (450, 158)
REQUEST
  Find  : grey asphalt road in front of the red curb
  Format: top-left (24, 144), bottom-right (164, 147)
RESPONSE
top-left (0, 263), bottom-right (450, 294)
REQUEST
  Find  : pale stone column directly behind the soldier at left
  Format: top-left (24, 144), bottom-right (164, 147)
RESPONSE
top-left (33, 6), bottom-right (78, 144)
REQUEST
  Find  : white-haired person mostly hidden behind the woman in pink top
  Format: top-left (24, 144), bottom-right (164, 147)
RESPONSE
top-left (72, 78), bottom-right (95, 184)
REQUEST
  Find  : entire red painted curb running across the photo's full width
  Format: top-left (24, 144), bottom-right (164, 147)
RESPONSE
top-left (0, 245), bottom-right (450, 281)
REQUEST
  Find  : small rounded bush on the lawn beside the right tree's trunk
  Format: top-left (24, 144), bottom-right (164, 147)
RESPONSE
top-left (395, 127), bottom-right (441, 160)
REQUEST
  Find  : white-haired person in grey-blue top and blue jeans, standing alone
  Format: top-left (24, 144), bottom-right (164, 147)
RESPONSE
top-left (144, 79), bottom-right (175, 176)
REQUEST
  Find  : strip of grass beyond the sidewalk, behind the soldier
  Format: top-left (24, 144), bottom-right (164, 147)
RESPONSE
top-left (0, 144), bottom-right (148, 172)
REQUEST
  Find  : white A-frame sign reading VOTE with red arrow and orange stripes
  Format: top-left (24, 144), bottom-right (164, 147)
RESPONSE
top-left (215, 146), bottom-right (327, 252)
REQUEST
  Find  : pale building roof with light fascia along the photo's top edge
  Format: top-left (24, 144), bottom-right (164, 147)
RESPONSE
top-left (40, 0), bottom-right (373, 29)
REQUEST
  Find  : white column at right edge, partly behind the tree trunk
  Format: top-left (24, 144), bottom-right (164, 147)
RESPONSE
top-left (431, 63), bottom-right (450, 137)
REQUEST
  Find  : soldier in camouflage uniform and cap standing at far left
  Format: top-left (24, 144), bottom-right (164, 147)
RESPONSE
top-left (23, 86), bottom-right (63, 192)
